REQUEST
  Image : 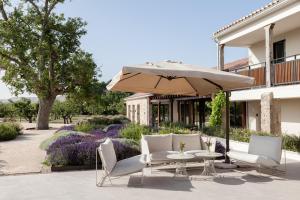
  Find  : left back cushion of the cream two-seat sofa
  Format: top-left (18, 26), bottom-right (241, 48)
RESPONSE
top-left (143, 134), bottom-right (172, 153)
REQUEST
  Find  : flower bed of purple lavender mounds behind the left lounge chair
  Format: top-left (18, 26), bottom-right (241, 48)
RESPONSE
top-left (41, 115), bottom-right (140, 171)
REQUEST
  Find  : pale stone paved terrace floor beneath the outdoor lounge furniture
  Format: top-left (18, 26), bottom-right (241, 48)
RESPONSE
top-left (0, 161), bottom-right (300, 200)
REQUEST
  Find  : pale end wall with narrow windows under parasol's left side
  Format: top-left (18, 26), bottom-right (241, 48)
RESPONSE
top-left (126, 98), bottom-right (150, 125)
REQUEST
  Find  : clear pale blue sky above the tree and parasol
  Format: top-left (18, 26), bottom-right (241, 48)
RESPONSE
top-left (0, 0), bottom-right (271, 99)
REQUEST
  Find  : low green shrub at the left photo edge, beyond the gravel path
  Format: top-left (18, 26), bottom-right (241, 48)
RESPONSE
top-left (0, 122), bottom-right (22, 141)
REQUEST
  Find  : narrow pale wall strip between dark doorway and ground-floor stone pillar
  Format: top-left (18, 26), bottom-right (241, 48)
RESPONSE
top-left (247, 101), bottom-right (260, 131)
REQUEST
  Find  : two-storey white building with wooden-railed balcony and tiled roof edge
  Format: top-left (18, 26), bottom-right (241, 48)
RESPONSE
top-left (214, 0), bottom-right (300, 135)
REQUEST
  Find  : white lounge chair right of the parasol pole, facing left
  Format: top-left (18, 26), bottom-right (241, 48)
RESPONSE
top-left (227, 135), bottom-right (286, 172)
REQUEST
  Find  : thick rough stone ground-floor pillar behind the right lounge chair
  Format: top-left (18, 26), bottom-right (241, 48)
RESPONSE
top-left (260, 92), bottom-right (281, 135)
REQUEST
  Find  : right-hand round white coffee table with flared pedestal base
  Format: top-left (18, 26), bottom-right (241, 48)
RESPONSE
top-left (195, 151), bottom-right (223, 176)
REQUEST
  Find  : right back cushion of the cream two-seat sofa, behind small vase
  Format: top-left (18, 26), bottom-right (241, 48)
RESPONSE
top-left (173, 134), bottom-right (201, 151)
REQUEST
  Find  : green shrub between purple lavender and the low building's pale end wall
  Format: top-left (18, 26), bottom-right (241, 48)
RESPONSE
top-left (121, 124), bottom-right (151, 142)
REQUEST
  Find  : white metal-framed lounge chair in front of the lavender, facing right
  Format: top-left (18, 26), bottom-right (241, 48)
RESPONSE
top-left (96, 138), bottom-right (146, 187)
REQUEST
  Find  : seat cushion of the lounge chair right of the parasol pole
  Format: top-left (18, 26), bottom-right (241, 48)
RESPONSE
top-left (227, 151), bottom-right (279, 167)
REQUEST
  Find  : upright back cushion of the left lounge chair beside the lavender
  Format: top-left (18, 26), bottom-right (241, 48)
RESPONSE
top-left (99, 138), bottom-right (117, 172)
